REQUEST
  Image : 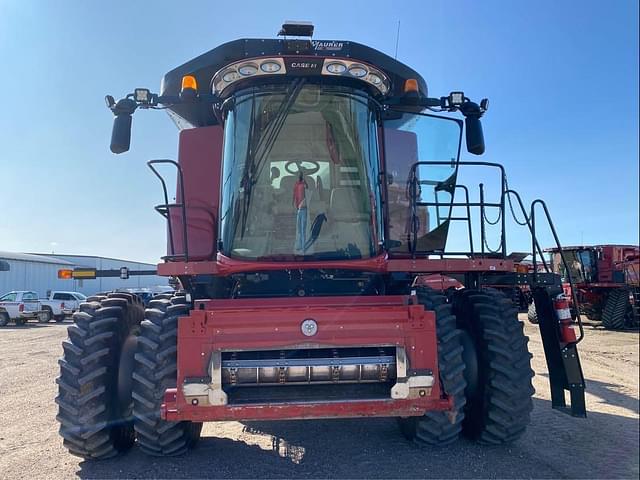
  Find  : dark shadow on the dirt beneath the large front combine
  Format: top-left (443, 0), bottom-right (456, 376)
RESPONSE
top-left (77, 398), bottom-right (638, 479)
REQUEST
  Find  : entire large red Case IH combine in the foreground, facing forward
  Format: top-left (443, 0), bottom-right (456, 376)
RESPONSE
top-left (56, 23), bottom-right (586, 459)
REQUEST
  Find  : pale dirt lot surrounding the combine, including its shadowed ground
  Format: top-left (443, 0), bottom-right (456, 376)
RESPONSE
top-left (0, 316), bottom-right (639, 479)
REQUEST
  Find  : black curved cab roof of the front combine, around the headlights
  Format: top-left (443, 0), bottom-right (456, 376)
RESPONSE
top-left (160, 39), bottom-right (427, 128)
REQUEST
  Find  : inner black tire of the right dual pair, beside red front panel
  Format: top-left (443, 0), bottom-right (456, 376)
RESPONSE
top-left (399, 287), bottom-right (467, 446)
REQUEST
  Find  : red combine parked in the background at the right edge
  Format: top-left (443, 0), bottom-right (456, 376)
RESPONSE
top-left (536, 245), bottom-right (640, 329)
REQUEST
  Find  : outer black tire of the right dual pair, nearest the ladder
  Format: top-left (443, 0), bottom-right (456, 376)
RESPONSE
top-left (453, 290), bottom-right (534, 445)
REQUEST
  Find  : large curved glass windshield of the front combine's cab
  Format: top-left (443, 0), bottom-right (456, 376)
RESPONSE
top-left (220, 82), bottom-right (381, 260)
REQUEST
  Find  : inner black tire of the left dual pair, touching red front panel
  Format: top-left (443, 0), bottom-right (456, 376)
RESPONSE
top-left (133, 296), bottom-right (202, 456)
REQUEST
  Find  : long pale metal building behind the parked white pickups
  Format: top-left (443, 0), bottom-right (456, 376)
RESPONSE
top-left (0, 251), bottom-right (168, 297)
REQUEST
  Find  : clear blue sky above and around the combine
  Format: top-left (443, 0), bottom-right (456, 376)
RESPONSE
top-left (0, 0), bottom-right (639, 261)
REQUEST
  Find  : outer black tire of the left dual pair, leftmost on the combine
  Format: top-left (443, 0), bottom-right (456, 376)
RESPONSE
top-left (56, 293), bottom-right (143, 459)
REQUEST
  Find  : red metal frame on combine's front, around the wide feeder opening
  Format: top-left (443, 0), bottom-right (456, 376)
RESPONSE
top-left (165, 296), bottom-right (449, 420)
